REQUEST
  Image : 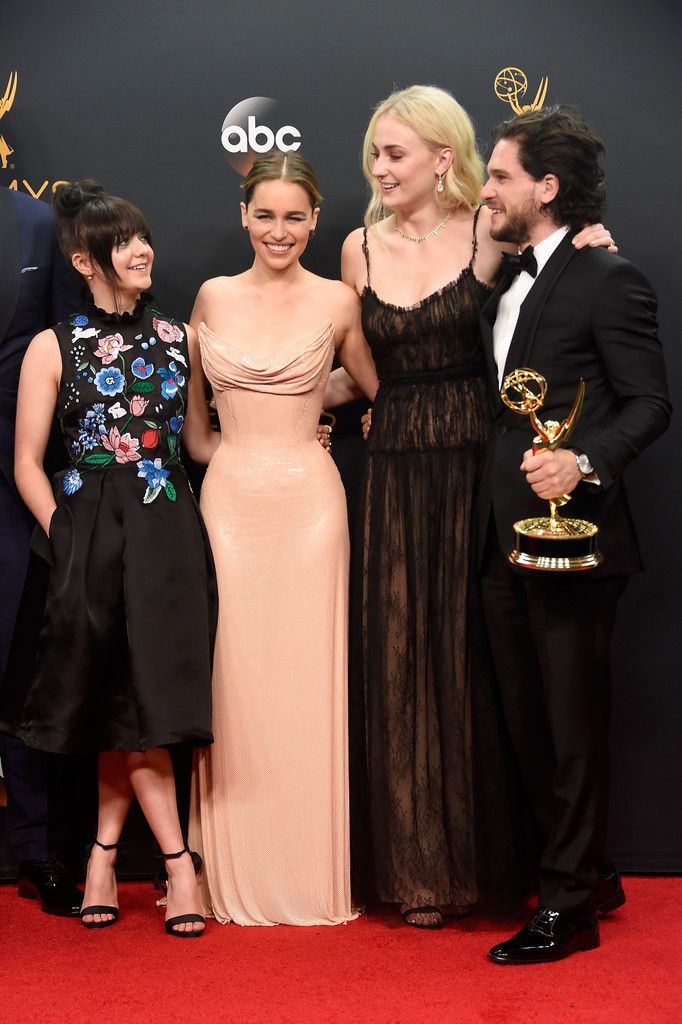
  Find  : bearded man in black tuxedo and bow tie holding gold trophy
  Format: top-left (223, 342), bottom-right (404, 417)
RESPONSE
top-left (479, 108), bottom-right (671, 964)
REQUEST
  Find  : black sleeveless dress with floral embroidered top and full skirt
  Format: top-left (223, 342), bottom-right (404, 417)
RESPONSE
top-left (0, 295), bottom-right (217, 754)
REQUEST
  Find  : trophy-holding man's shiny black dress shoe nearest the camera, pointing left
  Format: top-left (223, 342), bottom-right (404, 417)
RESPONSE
top-left (487, 907), bottom-right (599, 964)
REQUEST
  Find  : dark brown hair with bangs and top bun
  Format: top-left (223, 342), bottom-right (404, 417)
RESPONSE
top-left (53, 178), bottom-right (152, 297)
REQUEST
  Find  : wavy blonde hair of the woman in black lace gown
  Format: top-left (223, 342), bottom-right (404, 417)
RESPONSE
top-left (363, 85), bottom-right (483, 227)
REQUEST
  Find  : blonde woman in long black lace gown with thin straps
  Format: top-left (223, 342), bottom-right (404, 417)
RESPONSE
top-left (327, 86), bottom-right (614, 928)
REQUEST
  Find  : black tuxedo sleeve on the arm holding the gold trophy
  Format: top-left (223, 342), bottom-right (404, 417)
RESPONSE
top-left (572, 260), bottom-right (672, 488)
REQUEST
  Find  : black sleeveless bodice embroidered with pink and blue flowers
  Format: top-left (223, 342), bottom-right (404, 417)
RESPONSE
top-left (54, 294), bottom-right (189, 504)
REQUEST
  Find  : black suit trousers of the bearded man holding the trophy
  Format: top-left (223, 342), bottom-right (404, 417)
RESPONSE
top-left (481, 529), bottom-right (628, 915)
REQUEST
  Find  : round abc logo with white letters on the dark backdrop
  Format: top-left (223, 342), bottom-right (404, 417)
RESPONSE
top-left (220, 96), bottom-right (301, 175)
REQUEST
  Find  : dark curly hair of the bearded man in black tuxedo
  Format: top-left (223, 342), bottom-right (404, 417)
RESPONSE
top-left (493, 106), bottom-right (605, 230)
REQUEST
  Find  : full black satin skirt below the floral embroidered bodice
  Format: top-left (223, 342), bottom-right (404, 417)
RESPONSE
top-left (5, 466), bottom-right (217, 754)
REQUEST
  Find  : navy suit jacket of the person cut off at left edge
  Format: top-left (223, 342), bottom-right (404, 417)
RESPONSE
top-left (0, 188), bottom-right (79, 484)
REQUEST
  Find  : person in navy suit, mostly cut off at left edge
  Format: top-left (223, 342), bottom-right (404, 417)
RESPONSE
top-left (0, 188), bottom-right (82, 914)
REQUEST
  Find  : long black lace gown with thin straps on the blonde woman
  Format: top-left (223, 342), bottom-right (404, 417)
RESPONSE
top-left (351, 218), bottom-right (524, 911)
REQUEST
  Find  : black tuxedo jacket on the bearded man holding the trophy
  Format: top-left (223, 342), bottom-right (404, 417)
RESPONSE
top-left (477, 232), bottom-right (671, 578)
